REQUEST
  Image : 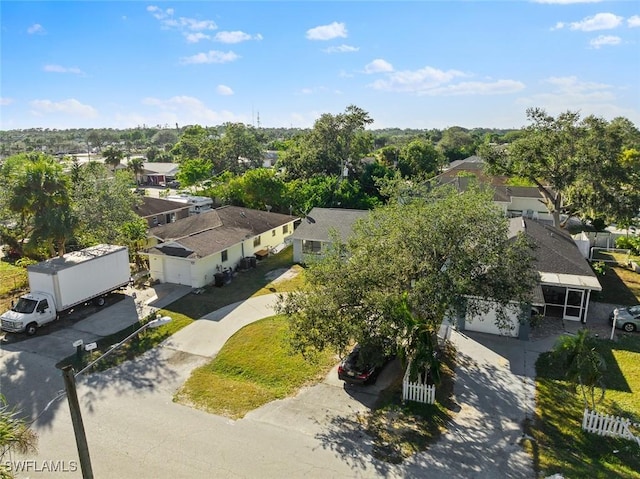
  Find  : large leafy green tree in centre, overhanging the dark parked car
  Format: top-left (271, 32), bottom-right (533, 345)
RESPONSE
top-left (278, 188), bottom-right (537, 376)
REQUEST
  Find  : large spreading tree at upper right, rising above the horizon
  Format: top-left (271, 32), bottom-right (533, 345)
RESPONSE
top-left (480, 108), bottom-right (637, 226)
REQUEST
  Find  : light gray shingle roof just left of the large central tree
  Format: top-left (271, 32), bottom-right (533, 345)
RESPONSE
top-left (291, 208), bottom-right (369, 241)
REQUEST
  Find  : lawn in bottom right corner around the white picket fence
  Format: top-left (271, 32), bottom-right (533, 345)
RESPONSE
top-left (531, 334), bottom-right (640, 478)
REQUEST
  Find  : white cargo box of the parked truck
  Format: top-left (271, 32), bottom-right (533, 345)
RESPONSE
top-left (27, 244), bottom-right (130, 311)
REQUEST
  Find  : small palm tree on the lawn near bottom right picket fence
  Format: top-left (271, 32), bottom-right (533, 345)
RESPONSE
top-left (551, 329), bottom-right (607, 410)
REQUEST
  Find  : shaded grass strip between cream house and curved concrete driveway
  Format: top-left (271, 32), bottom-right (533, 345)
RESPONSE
top-left (167, 246), bottom-right (304, 319)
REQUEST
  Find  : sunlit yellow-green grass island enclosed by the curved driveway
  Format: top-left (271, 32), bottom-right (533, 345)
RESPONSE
top-left (174, 316), bottom-right (336, 419)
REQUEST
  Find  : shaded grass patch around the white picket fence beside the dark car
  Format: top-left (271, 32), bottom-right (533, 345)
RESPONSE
top-left (360, 344), bottom-right (456, 464)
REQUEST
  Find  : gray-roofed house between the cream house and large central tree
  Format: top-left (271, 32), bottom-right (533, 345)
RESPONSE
top-left (291, 208), bottom-right (369, 263)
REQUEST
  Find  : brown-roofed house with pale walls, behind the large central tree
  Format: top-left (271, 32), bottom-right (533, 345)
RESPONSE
top-left (436, 156), bottom-right (553, 222)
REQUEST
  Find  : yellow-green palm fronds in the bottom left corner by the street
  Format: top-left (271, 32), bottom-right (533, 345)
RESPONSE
top-left (0, 395), bottom-right (38, 479)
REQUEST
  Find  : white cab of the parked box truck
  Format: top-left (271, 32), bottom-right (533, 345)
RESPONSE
top-left (0, 293), bottom-right (57, 336)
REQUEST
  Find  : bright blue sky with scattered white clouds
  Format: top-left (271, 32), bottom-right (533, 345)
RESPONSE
top-left (0, 0), bottom-right (640, 130)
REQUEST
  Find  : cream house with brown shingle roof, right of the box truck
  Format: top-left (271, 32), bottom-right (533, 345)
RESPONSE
top-left (145, 206), bottom-right (297, 288)
